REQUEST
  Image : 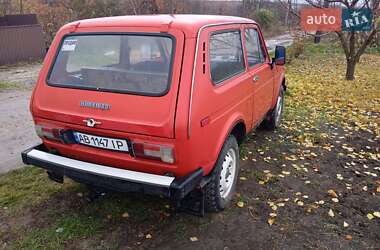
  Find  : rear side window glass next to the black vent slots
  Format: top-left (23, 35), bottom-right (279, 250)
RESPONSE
top-left (210, 30), bottom-right (245, 84)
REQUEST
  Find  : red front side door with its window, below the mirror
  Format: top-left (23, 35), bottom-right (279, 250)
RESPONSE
top-left (244, 25), bottom-right (274, 124)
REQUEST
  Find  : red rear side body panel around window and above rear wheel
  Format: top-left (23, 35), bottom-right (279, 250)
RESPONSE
top-left (186, 24), bottom-right (252, 174)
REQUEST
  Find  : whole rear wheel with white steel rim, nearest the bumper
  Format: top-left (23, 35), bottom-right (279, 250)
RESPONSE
top-left (205, 135), bottom-right (239, 212)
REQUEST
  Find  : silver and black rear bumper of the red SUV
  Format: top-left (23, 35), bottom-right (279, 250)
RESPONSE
top-left (21, 144), bottom-right (203, 199)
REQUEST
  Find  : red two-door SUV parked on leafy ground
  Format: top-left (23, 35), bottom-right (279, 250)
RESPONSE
top-left (22, 15), bottom-right (286, 211)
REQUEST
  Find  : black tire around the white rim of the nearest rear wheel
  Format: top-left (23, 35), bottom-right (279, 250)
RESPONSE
top-left (205, 135), bottom-right (239, 212)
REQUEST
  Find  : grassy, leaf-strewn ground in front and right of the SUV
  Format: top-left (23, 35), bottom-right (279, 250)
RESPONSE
top-left (0, 44), bottom-right (380, 249)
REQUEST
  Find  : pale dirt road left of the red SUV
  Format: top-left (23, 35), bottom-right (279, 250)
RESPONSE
top-left (0, 62), bottom-right (42, 174)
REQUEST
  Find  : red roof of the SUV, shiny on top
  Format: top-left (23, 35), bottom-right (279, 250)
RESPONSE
top-left (68, 14), bottom-right (256, 37)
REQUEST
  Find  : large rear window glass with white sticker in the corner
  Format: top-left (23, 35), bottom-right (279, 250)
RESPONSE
top-left (48, 34), bottom-right (174, 96)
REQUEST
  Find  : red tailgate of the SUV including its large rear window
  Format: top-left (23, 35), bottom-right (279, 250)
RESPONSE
top-left (32, 27), bottom-right (184, 138)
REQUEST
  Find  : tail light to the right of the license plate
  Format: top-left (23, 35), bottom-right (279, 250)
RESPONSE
top-left (133, 143), bottom-right (174, 163)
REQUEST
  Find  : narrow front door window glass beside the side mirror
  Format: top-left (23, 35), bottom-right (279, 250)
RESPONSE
top-left (245, 29), bottom-right (265, 67)
